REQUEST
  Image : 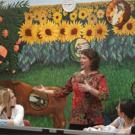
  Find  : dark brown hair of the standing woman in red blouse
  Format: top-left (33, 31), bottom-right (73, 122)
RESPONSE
top-left (81, 48), bottom-right (100, 70)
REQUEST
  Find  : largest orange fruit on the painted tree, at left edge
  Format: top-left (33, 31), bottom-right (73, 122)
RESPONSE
top-left (0, 45), bottom-right (8, 64)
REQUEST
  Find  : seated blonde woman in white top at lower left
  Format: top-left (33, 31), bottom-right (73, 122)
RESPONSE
top-left (0, 88), bottom-right (24, 126)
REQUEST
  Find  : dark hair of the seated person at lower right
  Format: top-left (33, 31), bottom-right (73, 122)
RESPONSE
top-left (119, 99), bottom-right (135, 119)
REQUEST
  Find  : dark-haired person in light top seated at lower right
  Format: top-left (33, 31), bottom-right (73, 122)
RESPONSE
top-left (84, 99), bottom-right (135, 133)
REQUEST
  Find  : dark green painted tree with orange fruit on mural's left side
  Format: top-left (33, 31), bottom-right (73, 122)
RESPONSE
top-left (0, 1), bottom-right (29, 73)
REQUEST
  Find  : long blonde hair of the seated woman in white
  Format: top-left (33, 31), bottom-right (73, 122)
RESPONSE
top-left (0, 88), bottom-right (12, 107)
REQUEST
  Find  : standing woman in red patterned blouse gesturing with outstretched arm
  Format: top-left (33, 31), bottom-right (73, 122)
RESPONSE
top-left (33, 49), bottom-right (108, 130)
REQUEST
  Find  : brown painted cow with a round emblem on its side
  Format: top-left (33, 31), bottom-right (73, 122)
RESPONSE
top-left (0, 80), bottom-right (66, 128)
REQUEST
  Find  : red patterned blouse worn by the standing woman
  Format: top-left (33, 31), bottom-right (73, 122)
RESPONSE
top-left (57, 72), bottom-right (109, 125)
